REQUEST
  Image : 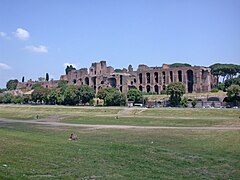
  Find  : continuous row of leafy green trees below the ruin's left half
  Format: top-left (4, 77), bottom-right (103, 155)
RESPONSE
top-left (0, 81), bottom-right (143, 106)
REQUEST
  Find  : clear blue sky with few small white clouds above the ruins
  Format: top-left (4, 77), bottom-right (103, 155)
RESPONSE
top-left (0, 0), bottom-right (240, 87)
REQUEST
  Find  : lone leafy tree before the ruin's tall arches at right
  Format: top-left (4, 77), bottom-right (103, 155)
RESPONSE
top-left (167, 82), bottom-right (186, 106)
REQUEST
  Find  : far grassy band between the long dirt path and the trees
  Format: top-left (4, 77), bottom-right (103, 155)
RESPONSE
top-left (0, 105), bottom-right (240, 127)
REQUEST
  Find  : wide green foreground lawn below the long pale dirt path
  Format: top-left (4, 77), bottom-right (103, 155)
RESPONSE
top-left (0, 123), bottom-right (240, 179)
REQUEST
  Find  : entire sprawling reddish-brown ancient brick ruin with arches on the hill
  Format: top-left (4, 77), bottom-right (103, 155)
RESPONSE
top-left (18, 61), bottom-right (213, 94)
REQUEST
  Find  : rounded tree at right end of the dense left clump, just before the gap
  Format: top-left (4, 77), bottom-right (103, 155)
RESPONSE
top-left (79, 85), bottom-right (95, 104)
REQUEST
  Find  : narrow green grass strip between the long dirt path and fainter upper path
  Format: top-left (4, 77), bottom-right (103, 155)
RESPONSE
top-left (60, 116), bottom-right (240, 127)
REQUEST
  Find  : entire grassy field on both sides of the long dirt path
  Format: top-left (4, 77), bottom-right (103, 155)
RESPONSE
top-left (0, 105), bottom-right (240, 180)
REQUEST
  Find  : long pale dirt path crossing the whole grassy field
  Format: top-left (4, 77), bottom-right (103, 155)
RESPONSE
top-left (0, 118), bottom-right (240, 130)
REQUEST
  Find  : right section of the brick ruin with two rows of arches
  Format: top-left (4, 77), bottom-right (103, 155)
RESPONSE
top-left (137, 64), bottom-right (212, 94)
